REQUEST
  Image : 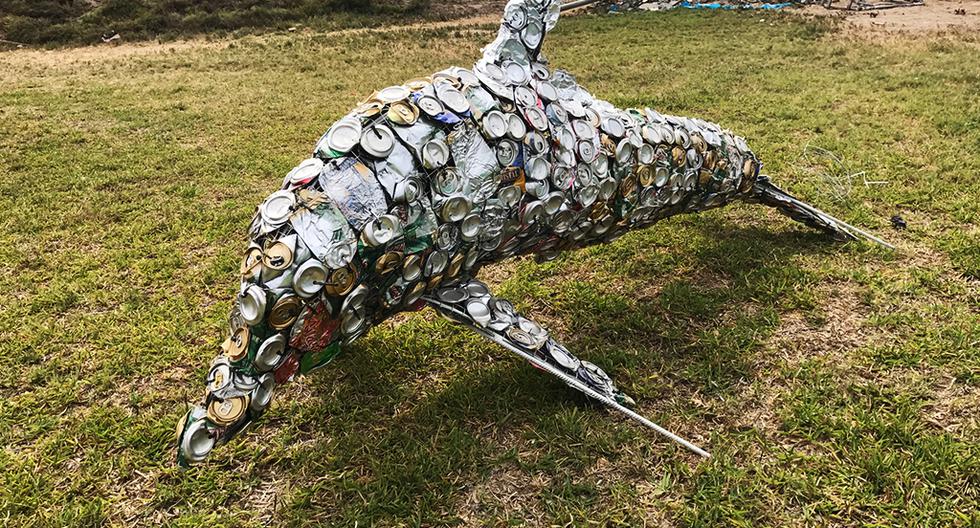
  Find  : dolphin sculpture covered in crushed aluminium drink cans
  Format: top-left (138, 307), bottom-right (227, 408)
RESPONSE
top-left (177, 0), bottom-right (887, 466)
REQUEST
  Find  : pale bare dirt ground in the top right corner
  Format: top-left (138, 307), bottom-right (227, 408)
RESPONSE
top-left (803, 0), bottom-right (980, 36)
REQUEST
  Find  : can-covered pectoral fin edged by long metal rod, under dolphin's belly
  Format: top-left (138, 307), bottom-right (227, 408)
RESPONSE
top-left (424, 280), bottom-right (711, 457)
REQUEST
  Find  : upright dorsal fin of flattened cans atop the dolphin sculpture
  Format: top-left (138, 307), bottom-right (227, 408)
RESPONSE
top-left (483, 0), bottom-right (561, 66)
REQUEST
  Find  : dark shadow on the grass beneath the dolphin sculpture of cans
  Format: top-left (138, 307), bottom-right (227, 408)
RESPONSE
top-left (272, 215), bottom-right (848, 524)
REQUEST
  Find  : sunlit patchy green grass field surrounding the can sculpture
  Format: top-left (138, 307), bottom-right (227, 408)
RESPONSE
top-left (0, 12), bottom-right (980, 527)
